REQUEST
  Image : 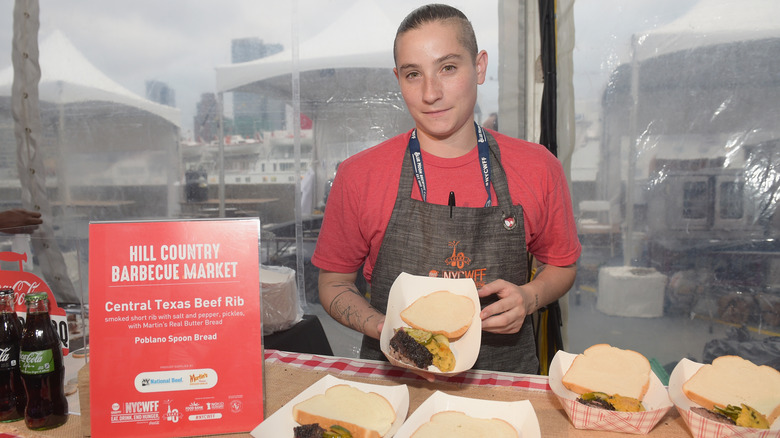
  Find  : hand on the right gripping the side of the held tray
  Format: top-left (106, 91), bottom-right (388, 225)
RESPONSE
top-left (478, 280), bottom-right (531, 334)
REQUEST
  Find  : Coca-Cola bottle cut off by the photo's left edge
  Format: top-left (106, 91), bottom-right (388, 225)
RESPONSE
top-left (0, 289), bottom-right (27, 422)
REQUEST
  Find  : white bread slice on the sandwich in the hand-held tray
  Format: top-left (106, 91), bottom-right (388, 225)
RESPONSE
top-left (401, 290), bottom-right (475, 339)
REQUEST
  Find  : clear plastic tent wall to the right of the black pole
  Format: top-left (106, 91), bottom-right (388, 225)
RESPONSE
top-left (569, 0), bottom-right (780, 367)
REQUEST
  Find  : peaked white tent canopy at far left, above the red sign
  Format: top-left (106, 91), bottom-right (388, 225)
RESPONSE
top-left (0, 31), bottom-right (180, 127)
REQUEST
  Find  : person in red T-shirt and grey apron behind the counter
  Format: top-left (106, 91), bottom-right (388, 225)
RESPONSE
top-left (312, 4), bottom-right (581, 374)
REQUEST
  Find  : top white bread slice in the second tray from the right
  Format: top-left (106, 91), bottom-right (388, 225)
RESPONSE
top-left (561, 344), bottom-right (650, 400)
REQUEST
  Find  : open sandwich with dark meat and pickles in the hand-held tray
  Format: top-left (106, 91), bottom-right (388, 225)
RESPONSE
top-left (389, 291), bottom-right (476, 372)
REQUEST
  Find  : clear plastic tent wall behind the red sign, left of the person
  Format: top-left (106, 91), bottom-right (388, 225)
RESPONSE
top-left (0, 0), bottom-right (497, 314)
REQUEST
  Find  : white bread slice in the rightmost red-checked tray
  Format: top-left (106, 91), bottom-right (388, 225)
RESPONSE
top-left (682, 356), bottom-right (780, 424)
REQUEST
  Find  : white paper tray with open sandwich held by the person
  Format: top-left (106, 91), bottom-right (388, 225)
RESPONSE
top-left (379, 272), bottom-right (482, 375)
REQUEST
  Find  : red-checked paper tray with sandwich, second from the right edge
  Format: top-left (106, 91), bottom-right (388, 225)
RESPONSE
top-left (549, 344), bottom-right (672, 434)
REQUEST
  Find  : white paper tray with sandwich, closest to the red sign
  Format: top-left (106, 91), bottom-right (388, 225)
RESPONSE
top-left (251, 375), bottom-right (409, 438)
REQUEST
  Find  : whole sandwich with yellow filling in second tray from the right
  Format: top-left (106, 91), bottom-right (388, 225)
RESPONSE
top-left (561, 344), bottom-right (651, 412)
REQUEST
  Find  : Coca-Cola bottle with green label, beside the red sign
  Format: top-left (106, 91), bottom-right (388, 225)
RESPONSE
top-left (19, 292), bottom-right (68, 430)
